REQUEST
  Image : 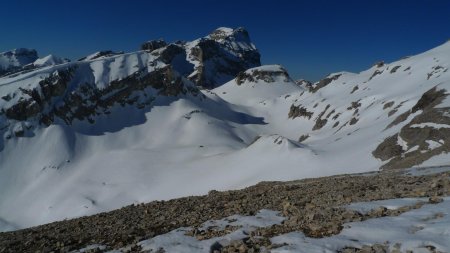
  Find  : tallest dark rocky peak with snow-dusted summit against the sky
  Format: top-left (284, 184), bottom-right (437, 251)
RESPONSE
top-left (134, 27), bottom-right (261, 89)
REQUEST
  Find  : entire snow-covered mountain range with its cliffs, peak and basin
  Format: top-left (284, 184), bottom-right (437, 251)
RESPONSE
top-left (0, 28), bottom-right (450, 230)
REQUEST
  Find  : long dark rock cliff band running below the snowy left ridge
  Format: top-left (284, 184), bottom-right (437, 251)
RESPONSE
top-left (5, 65), bottom-right (196, 128)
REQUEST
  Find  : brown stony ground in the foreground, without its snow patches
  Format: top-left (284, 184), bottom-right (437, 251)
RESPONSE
top-left (0, 167), bottom-right (450, 252)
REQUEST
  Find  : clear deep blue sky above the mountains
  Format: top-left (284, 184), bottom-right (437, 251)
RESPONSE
top-left (0, 0), bottom-right (450, 80)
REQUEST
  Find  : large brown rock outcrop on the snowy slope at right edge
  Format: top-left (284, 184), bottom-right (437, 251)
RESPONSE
top-left (372, 87), bottom-right (450, 169)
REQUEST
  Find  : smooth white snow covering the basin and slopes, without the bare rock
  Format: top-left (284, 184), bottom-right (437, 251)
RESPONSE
top-left (0, 43), bottom-right (450, 231)
